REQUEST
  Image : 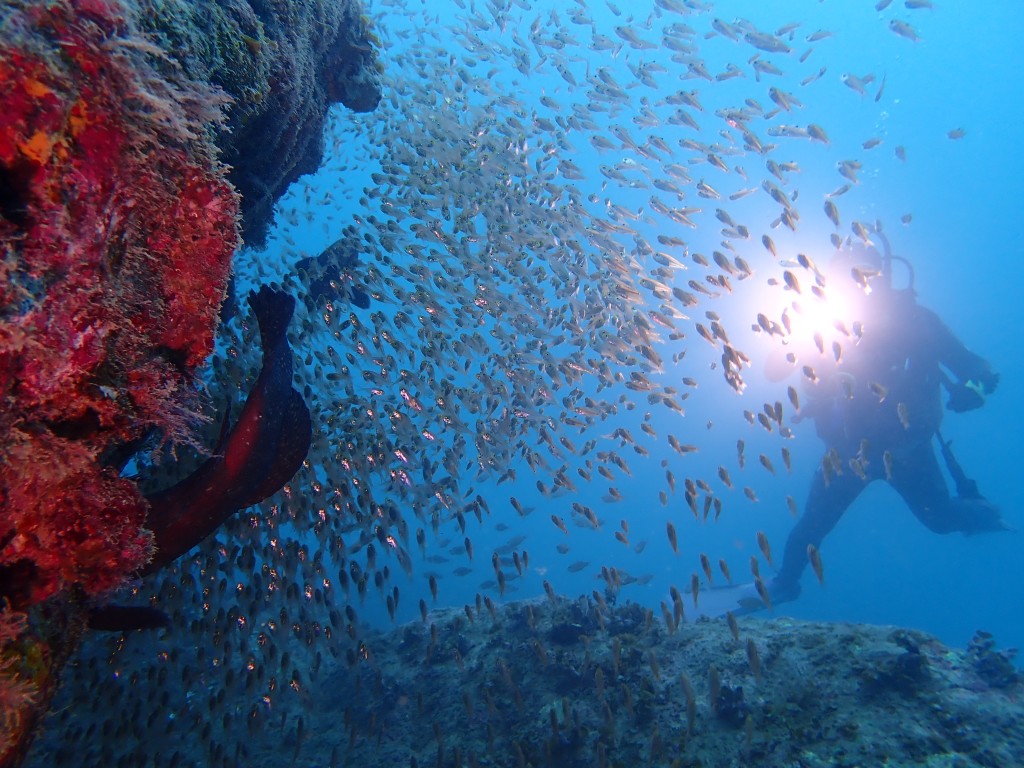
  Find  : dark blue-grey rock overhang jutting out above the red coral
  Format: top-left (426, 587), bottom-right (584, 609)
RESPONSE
top-left (130, 0), bottom-right (381, 247)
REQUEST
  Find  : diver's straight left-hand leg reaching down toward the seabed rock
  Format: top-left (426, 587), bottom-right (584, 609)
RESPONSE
top-left (769, 468), bottom-right (867, 601)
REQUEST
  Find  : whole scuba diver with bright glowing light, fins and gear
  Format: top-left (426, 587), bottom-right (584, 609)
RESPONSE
top-left (698, 231), bottom-right (1011, 615)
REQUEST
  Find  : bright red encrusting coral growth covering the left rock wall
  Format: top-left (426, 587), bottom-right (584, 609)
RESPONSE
top-left (0, 0), bottom-right (238, 608)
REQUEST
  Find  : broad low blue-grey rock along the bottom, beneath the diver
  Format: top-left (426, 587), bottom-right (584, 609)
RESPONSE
top-left (288, 597), bottom-right (1024, 768)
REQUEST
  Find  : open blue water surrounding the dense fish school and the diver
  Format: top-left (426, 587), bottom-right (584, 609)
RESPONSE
top-left (240, 0), bottom-right (1024, 663)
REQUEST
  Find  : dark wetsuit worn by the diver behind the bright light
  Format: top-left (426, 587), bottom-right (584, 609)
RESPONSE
top-left (771, 290), bottom-right (1002, 599)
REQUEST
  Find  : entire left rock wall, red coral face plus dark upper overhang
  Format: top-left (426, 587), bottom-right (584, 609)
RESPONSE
top-left (0, 0), bottom-right (379, 765)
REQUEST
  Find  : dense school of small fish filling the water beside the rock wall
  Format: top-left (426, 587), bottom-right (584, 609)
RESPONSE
top-left (28, 0), bottom-right (966, 765)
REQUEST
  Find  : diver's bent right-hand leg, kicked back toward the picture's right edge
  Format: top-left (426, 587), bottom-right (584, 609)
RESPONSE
top-left (889, 443), bottom-right (1007, 534)
